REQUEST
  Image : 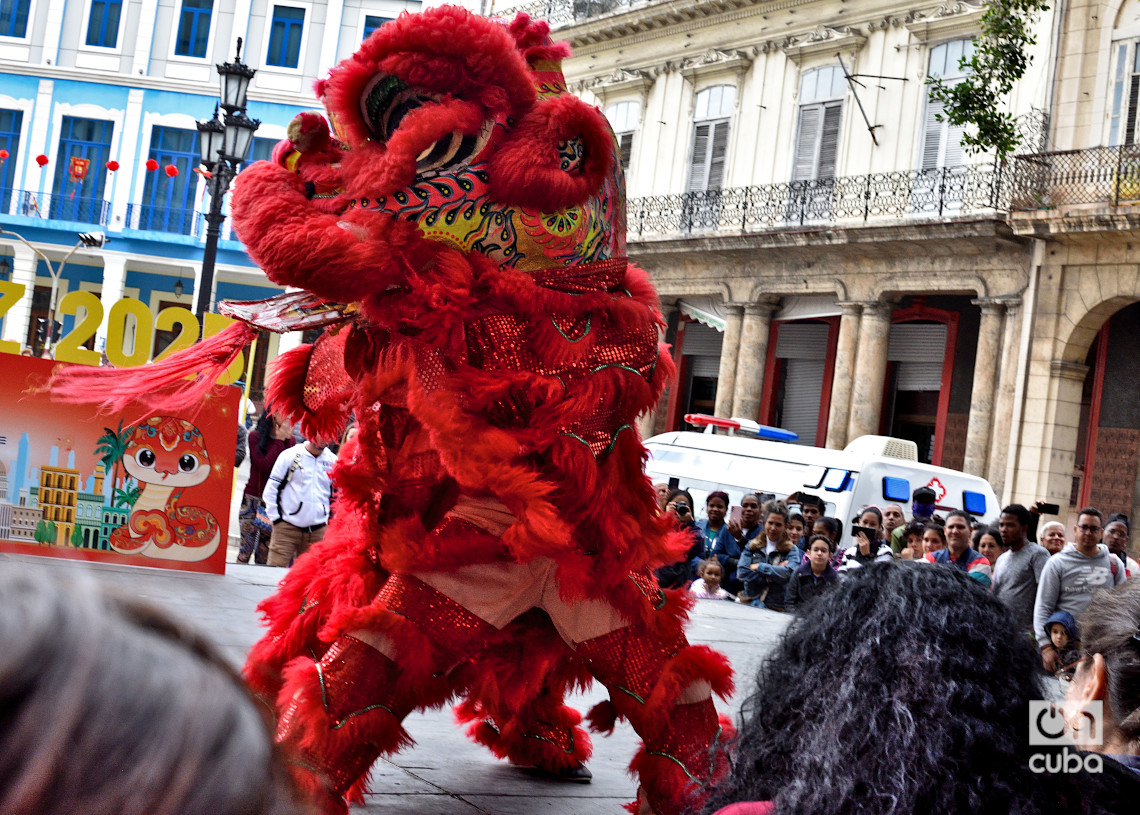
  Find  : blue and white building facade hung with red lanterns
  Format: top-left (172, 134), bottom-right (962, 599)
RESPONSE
top-left (0, 0), bottom-right (420, 390)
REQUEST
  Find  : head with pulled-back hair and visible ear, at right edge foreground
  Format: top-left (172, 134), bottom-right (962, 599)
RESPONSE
top-left (1061, 578), bottom-right (1140, 756)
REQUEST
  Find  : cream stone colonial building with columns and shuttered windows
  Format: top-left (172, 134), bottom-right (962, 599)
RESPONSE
top-left (494, 0), bottom-right (1140, 515)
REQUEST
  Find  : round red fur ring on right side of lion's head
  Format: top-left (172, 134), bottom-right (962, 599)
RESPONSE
top-left (490, 93), bottom-right (614, 212)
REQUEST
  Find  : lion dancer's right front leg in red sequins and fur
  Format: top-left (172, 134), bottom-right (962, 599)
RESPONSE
top-left (576, 576), bottom-right (732, 815)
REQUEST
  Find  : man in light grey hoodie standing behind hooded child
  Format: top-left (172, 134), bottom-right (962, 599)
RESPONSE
top-left (1033, 507), bottom-right (1124, 674)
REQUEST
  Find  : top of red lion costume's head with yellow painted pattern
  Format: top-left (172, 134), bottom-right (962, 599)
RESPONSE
top-left (317, 6), bottom-right (625, 270)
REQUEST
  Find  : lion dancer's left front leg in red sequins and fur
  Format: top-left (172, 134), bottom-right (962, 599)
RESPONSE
top-left (277, 574), bottom-right (495, 814)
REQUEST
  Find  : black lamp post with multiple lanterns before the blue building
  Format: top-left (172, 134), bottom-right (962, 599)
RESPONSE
top-left (194, 38), bottom-right (261, 336)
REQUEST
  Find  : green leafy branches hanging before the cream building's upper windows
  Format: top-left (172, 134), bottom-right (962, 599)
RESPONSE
top-left (927, 0), bottom-right (1050, 160)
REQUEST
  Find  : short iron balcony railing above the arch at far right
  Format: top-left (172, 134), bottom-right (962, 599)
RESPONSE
top-left (1011, 145), bottom-right (1140, 210)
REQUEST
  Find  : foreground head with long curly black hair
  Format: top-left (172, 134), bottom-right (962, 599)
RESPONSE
top-left (706, 562), bottom-right (1140, 815)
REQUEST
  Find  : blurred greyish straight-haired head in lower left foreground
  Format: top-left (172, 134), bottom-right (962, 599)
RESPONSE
top-left (0, 565), bottom-right (307, 815)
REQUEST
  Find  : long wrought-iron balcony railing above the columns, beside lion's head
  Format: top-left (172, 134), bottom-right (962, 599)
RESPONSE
top-left (626, 164), bottom-right (1009, 237)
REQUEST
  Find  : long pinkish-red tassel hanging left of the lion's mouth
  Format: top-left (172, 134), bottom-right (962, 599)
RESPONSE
top-left (48, 323), bottom-right (258, 413)
